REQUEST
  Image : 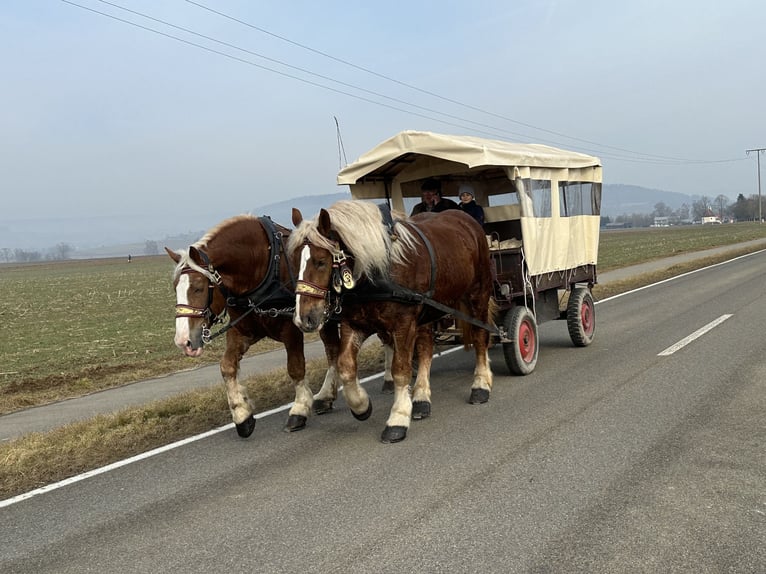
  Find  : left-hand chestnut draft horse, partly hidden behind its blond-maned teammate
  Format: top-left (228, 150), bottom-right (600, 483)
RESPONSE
top-left (165, 215), bottom-right (338, 437)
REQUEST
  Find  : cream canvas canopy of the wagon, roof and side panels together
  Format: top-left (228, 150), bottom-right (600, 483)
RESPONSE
top-left (337, 131), bottom-right (602, 282)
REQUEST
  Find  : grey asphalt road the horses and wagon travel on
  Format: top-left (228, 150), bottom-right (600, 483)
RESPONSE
top-left (0, 249), bottom-right (766, 574)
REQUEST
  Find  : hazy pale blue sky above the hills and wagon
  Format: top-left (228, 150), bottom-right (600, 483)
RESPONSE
top-left (0, 0), bottom-right (766, 232)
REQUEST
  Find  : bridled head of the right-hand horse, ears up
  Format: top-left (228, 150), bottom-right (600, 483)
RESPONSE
top-left (290, 209), bottom-right (342, 333)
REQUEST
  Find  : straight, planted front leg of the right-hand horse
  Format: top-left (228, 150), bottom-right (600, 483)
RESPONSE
top-left (380, 319), bottom-right (417, 443)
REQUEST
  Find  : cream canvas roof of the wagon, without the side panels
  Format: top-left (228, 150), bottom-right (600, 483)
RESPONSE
top-left (338, 131), bottom-right (601, 185)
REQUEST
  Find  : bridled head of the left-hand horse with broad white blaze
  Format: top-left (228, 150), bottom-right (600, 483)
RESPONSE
top-left (165, 246), bottom-right (226, 357)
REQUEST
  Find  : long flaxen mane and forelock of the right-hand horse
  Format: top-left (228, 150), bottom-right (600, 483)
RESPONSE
top-left (289, 200), bottom-right (416, 279)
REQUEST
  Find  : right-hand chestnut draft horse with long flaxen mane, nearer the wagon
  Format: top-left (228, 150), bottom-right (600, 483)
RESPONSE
top-left (288, 201), bottom-right (493, 443)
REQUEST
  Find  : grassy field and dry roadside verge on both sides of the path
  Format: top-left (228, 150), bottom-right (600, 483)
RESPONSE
top-left (0, 224), bottom-right (766, 498)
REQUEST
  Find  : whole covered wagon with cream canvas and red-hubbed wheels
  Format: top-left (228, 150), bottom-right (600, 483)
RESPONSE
top-left (338, 131), bottom-right (602, 375)
